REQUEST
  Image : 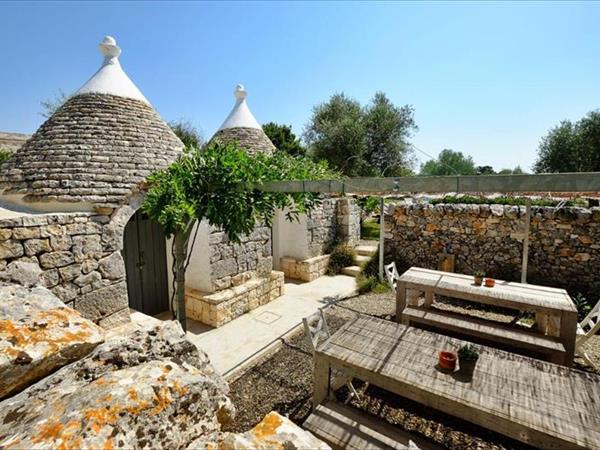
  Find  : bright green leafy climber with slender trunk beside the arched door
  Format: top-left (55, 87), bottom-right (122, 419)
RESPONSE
top-left (142, 141), bottom-right (336, 329)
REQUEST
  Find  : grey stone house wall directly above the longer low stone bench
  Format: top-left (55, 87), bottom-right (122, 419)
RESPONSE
top-left (208, 226), bottom-right (273, 292)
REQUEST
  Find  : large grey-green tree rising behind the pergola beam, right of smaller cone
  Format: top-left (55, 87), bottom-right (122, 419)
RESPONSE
top-left (304, 92), bottom-right (417, 176)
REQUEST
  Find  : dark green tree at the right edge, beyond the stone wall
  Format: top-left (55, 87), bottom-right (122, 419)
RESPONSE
top-left (534, 110), bottom-right (600, 173)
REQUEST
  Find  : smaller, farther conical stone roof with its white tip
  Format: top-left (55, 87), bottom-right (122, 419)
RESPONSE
top-left (211, 84), bottom-right (275, 154)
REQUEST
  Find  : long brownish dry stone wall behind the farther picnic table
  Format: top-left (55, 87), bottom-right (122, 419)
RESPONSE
top-left (385, 204), bottom-right (600, 298)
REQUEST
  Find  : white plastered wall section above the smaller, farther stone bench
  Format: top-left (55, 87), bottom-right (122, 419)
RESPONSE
top-left (273, 211), bottom-right (310, 270)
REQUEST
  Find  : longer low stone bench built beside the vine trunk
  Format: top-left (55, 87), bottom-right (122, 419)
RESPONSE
top-left (185, 271), bottom-right (284, 327)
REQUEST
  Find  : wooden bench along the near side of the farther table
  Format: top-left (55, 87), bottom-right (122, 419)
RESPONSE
top-left (402, 306), bottom-right (566, 364)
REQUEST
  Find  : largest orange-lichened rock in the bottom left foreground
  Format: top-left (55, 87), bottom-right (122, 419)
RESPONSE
top-left (0, 322), bottom-right (235, 449)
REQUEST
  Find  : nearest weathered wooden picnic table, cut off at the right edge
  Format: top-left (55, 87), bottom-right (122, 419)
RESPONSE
top-left (313, 316), bottom-right (600, 449)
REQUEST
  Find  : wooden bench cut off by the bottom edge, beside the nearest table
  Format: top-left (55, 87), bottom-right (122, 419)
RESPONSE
top-left (302, 401), bottom-right (439, 450)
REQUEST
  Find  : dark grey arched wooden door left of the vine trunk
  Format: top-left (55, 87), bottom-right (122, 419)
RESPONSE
top-left (123, 211), bottom-right (169, 316)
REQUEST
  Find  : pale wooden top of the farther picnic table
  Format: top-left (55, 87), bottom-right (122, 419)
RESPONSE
top-left (398, 267), bottom-right (577, 313)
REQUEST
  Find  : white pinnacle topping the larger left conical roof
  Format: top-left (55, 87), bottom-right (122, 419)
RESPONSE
top-left (75, 36), bottom-right (150, 104)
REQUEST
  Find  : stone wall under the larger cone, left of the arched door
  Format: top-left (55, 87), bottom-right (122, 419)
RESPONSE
top-left (0, 206), bottom-right (131, 328)
